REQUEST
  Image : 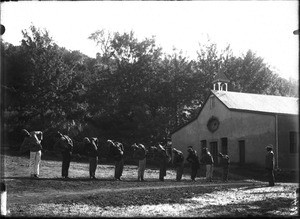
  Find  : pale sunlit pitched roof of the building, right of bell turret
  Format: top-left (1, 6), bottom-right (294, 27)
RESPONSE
top-left (212, 90), bottom-right (299, 115)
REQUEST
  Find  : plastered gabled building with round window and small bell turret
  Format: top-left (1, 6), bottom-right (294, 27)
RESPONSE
top-left (171, 74), bottom-right (299, 170)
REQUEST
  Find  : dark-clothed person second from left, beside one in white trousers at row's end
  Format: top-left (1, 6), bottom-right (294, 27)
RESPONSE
top-left (53, 132), bottom-right (73, 179)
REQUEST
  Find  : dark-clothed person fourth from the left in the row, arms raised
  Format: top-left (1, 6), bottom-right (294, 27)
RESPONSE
top-left (107, 140), bottom-right (124, 181)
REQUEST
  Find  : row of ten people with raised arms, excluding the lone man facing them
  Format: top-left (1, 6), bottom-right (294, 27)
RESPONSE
top-left (20, 129), bottom-right (230, 182)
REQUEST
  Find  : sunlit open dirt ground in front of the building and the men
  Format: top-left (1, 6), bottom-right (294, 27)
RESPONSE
top-left (1, 155), bottom-right (299, 217)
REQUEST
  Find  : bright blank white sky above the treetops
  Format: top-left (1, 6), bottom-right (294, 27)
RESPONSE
top-left (1, 0), bottom-right (299, 80)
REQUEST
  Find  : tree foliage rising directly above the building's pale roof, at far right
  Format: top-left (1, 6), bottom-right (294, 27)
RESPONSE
top-left (223, 50), bottom-right (297, 96)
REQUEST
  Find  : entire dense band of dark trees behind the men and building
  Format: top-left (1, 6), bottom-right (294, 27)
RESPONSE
top-left (1, 26), bottom-right (298, 149)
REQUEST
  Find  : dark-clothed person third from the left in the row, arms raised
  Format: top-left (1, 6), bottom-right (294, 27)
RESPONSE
top-left (83, 137), bottom-right (98, 179)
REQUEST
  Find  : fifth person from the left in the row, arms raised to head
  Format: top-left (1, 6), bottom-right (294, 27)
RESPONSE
top-left (132, 144), bottom-right (147, 181)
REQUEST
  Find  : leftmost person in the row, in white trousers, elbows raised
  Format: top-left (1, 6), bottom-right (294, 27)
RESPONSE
top-left (20, 129), bottom-right (43, 178)
